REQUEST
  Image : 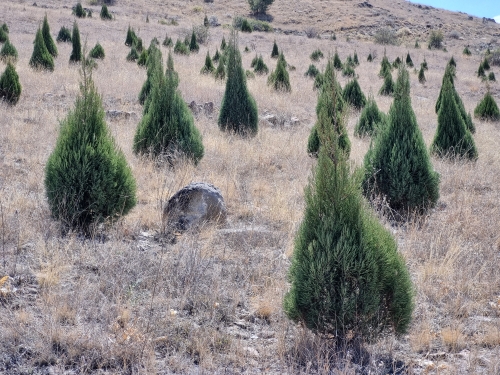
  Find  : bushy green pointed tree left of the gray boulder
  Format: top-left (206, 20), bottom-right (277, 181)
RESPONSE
top-left (45, 61), bottom-right (136, 234)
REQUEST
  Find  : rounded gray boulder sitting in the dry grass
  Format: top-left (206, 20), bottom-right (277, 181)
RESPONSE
top-left (163, 182), bottom-right (227, 232)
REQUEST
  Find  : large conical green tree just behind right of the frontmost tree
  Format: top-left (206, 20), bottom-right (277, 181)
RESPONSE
top-left (364, 67), bottom-right (439, 216)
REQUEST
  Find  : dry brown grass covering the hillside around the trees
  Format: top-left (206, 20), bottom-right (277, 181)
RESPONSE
top-left (0, 0), bottom-right (500, 374)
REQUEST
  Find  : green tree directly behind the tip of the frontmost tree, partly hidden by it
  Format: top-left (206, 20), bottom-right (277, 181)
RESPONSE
top-left (307, 59), bottom-right (351, 156)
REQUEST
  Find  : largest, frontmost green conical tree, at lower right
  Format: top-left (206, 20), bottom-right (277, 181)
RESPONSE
top-left (283, 103), bottom-right (414, 347)
